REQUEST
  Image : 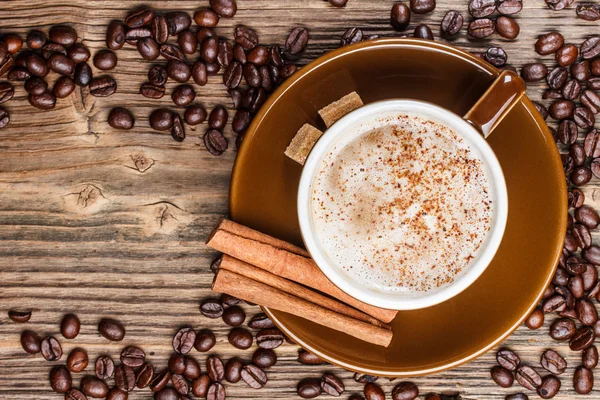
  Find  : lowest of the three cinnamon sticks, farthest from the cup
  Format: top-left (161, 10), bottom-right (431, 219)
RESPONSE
top-left (212, 269), bottom-right (393, 347)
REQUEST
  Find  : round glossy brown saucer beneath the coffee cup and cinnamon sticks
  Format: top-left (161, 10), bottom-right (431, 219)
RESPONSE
top-left (230, 39), bottom-right (567, 377)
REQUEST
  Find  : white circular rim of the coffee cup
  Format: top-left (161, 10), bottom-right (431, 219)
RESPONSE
top-left (297, 98), bottom-right (508, 310)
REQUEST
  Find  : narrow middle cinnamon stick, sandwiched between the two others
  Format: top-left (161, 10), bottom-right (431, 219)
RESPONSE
top-left (219, 255), bottom-right (391, 329)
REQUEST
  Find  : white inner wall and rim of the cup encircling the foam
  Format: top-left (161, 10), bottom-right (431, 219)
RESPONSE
top-left (298, 99), bottom-right (508, 310)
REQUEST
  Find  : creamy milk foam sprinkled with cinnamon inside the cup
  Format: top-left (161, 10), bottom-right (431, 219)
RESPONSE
top-left (311, 115), bottom-right (493, 292)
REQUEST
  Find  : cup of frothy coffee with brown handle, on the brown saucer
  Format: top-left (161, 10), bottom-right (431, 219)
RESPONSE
top-left (297, 71), bottom-right (525, 310)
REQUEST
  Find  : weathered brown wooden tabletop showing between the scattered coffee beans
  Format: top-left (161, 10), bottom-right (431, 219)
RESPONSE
top-left (0, 0), bottom-right (600, 399)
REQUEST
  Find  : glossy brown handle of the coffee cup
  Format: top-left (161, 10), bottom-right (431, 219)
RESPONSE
top-left (463, 70), bottom-right (525, 138)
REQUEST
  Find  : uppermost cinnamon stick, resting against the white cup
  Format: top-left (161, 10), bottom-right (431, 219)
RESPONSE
top-left (207, 220), bottom-right (397, 323)
